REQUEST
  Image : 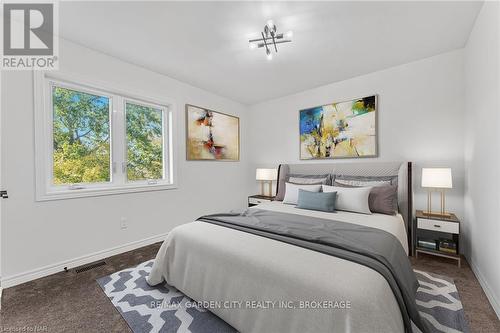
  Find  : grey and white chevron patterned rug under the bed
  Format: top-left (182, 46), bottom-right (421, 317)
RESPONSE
top-left (97, 260), bottom-right (469, 333)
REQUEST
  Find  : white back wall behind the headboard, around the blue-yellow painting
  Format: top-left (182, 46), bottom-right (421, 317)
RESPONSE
top-left (248, 50), bottom-right (464, 217)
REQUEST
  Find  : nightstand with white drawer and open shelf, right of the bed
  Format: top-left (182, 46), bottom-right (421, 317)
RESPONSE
top-left (415, 210), bottom-right (461, 267)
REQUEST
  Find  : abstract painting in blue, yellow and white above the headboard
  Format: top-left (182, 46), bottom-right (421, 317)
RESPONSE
top-left (299, 95), bottom-right (377, 160)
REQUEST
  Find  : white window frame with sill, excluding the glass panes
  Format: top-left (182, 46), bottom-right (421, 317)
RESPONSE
top-left (33, 71), bottom-right (177, 201)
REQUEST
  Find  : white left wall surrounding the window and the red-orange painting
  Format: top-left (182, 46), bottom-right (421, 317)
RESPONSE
top-left (1, 41), bottom-right (248, 285)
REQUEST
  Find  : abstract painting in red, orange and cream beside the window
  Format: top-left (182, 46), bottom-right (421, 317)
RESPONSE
top-left (186, 104), bottom-right (240, 161)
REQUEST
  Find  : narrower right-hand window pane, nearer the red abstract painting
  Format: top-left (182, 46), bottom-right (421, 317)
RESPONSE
top-left (125, 103), bottom-right (163, 181)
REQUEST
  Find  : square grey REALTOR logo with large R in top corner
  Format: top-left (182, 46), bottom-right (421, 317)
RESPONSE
top-left (1, 2), bottom-right (57, 70)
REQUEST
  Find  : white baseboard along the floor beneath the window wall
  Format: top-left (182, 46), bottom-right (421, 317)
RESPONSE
top-left (0, 233), bottom-right (167, 289)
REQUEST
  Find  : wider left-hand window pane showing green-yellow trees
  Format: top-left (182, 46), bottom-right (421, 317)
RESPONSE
top-left (52, 87), bottom-right (111, 185)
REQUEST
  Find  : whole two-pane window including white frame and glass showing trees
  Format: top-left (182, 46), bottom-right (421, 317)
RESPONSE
top-left (35, 74), bottom-right (175, 200)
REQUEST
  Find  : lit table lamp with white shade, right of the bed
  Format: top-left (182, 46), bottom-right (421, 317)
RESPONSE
top-left (422, 168), bottom-right (453, 217)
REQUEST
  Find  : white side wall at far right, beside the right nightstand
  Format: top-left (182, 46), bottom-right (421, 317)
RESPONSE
top-left (464, 2), bottom-right (500, 317)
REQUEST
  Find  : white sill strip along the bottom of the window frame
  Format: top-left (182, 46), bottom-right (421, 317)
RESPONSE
top-left (36, 184), bottom-right (178, 201)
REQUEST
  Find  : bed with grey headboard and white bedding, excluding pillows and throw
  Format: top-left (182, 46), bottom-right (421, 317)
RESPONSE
top-left (148, 162), bottom-right (419, 333)
